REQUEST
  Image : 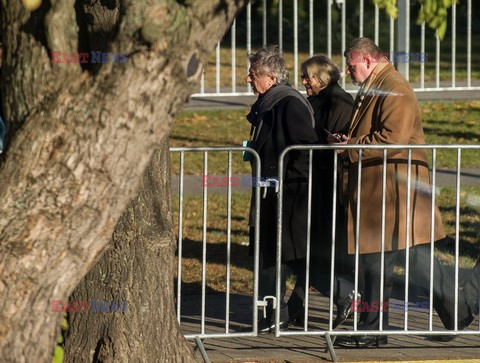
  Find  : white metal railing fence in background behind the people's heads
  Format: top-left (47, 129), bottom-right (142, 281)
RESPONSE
top-left (192, 0), bottom-right (480, 97)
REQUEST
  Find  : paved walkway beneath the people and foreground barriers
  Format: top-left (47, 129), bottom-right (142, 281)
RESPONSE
top-left (182, 290), bottom-right (480, 363)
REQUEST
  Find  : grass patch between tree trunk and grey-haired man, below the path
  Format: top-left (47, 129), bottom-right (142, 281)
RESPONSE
top-left (173, 193), bottom-right (253, 293)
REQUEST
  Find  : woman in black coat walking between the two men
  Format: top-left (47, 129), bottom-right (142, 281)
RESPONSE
top-left (289, 55), bottom-right (354, 328)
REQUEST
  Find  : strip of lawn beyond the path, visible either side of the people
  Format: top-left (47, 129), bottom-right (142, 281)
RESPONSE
top-left (170, 101), bottom-right (480, 175)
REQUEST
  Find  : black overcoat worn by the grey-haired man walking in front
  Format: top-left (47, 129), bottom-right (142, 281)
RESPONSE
top-left (250, 92), bottom-right (317, 266)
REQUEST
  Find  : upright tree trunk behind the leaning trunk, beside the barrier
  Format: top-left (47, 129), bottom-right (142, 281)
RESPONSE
top-left (65, 142), bottom-right (193, 362)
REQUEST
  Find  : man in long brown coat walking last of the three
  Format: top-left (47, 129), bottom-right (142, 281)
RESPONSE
top-left (332, 38), bottom-right (478, 347)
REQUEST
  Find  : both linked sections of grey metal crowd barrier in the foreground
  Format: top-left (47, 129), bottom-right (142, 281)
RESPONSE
top-left (170, 145), bottom-right (480, 361)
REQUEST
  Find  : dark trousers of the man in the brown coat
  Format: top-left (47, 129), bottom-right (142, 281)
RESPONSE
top-left (359, 244), bottom-right (474, 330)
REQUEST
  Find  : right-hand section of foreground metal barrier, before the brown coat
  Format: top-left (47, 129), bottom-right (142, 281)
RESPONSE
top-left (275, 145), bottom-right (480, 361)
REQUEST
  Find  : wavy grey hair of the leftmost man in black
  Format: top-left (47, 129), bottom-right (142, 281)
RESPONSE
top-left (248, 45), bottom-right (288, 83)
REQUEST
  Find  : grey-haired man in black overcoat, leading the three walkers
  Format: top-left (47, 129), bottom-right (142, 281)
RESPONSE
top-left (247, 46), bottom-right (317, 333)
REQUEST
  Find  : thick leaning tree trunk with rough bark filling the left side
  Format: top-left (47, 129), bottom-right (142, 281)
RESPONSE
top-left (0, 0), bottom-right (245, 362)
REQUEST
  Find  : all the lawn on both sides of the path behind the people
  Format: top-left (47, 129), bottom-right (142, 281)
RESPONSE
top-left (170, 101), bottom-right (480, 293)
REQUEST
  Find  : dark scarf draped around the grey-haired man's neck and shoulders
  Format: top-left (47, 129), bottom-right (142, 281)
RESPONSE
top-left (247, 82), bottom-right (315, 127)
